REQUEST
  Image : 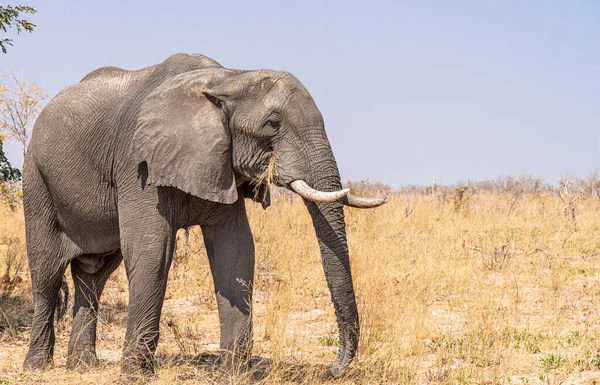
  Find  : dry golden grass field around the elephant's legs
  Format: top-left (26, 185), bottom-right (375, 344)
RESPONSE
top-left (0, 193), bottom-right (600, 385)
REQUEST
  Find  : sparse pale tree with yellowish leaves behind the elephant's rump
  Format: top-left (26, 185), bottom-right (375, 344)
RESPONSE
top-left (0, 68), bottom-right (48, 157)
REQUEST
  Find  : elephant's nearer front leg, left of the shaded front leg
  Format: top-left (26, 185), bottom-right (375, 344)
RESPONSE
top-left (121, 215), bottom-right (175, 379)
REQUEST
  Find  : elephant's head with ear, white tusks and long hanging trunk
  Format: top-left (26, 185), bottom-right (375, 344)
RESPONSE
top-left (133, 68), bottom-right (387, 374)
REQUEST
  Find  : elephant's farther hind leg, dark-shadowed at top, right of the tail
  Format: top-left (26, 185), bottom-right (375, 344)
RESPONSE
top-left (67, 250), bottom-right (123, 369)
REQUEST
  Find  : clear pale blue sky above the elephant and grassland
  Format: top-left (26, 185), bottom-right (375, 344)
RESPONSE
top-left (0, 0), bottom-right (600, 186)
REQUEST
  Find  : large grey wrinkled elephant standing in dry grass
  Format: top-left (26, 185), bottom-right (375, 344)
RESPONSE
top-left (23, 54), bottom-right (387, 376)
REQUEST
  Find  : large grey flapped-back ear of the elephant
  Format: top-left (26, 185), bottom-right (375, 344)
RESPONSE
top-left (131, 69), bottom-right (238, 204)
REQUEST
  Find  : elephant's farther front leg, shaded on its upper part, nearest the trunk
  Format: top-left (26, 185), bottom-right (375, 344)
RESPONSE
top-left (202, 198), bottom-right (254, 369)
